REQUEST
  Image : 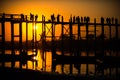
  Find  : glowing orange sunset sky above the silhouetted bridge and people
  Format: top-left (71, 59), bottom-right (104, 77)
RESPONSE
top-left (0, 0), bottom-right (120, 39)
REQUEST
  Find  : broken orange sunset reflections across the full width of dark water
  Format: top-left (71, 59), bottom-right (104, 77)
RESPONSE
top-left (0, 49), bottom-right (119, 75)
